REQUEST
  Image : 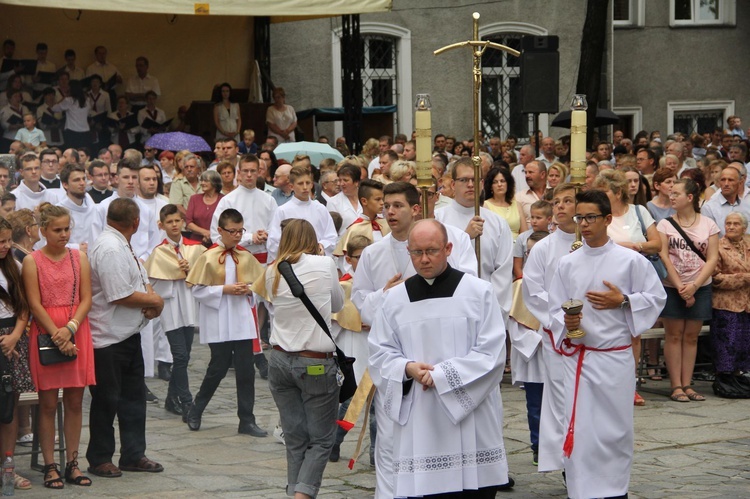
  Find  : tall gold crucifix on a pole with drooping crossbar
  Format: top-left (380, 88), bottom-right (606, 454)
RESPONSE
top-left (434, 12), bottom-right (521, 276)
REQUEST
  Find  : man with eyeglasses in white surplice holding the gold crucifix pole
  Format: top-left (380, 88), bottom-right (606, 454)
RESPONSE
top-left (435, 158), bottom-right (513, 321)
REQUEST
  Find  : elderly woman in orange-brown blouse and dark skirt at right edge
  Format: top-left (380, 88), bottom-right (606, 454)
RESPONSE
top-left (711, 212), bottom-right (750, 391)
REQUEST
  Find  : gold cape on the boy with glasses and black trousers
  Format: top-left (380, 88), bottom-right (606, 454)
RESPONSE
top-left (186, 244), bottom-right (265, 286)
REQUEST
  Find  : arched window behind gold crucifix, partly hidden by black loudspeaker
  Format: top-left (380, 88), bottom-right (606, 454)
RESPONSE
top-left (479, 23), bottom-right (547, 139)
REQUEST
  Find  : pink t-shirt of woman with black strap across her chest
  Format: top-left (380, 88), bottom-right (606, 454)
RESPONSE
top-left (656, 216), bottom-right (719, 287)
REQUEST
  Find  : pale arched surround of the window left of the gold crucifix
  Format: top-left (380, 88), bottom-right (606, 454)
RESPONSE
top-left (331, 22), bottom-right (415, 137)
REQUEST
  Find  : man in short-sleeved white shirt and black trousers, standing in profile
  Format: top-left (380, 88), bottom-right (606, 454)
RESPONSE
top-left (86, 198), bottom-right (164, 478)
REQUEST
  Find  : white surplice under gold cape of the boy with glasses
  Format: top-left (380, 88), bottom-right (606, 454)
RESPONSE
top-left (190, 245), bottom-right (258, 344)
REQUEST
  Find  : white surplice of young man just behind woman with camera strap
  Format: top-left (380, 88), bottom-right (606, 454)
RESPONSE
top-left (211, 185), bottom-right (278, 261)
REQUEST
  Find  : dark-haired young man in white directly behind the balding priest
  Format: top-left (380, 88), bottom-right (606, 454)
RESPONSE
top-left (352, 182), bottom-right (477, 499)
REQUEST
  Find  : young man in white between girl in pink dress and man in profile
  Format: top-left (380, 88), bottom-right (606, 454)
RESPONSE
top-left (57, 164), bottom-right (97, 253)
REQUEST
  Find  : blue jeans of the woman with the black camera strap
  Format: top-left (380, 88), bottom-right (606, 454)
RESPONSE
top-left (268, 350), bottom-right (339, 497)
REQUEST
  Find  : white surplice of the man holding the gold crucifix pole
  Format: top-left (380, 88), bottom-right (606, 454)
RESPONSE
top-left (435, 202), bottom-right (513, 324)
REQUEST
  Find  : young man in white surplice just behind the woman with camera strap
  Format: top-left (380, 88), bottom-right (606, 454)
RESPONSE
top-left (211, 154), bottom-right (277, 264)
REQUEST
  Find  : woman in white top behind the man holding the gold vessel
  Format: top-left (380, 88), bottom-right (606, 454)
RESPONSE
top-left (592, 170), bottom-right (662, 406)
